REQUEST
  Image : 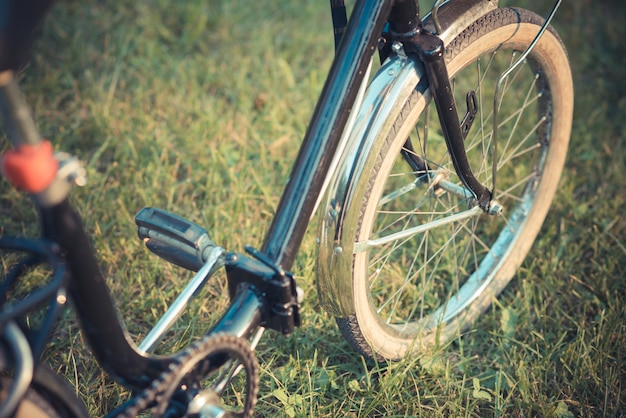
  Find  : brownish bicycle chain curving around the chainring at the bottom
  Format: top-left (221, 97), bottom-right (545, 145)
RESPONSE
top-left (117, 334), bottom-right (260, 418)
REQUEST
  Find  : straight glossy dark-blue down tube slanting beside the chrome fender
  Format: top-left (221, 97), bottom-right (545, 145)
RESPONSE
top-left (261, 0), bottom-right (392, 270)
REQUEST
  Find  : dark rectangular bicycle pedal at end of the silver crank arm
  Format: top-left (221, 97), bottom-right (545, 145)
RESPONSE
top-left (135, 207), bottom-right (217, 271)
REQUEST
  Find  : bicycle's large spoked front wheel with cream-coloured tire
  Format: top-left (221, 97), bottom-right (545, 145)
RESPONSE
top-left (332, 8), bottom-right (573, 360)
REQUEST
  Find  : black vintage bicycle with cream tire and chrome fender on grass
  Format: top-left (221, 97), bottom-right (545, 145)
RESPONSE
top-left (0, 0), bottom-right (573, 417)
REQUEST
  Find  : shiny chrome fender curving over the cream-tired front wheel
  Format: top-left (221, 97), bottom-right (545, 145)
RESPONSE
top-left (316, 0), bottom-right (497, 317)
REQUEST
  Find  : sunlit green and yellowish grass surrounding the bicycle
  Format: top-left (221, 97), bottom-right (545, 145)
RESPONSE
top-left (0, 0), bottom-right (626, 417)
